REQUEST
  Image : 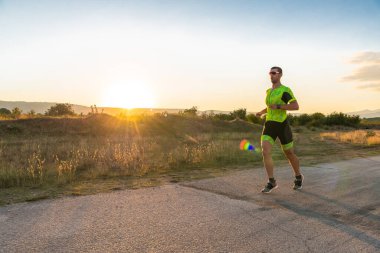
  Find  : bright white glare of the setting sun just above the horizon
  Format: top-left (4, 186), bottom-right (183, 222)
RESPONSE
top-left (103, 82), bottom-right (154, 109)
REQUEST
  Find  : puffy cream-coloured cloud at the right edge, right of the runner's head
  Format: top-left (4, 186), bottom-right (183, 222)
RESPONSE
top-left (342, 52), bottom-right (380, 91)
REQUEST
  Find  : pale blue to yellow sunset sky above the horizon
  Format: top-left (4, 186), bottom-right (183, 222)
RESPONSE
top-left (0, 0), bottom-right (380, 113)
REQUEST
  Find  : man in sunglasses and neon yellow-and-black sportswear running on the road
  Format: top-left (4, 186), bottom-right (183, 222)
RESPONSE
top-left (256, 67), bottom-right (303, 193)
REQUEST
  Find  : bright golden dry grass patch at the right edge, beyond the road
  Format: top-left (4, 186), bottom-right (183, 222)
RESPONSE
top-left (320, 130), bottom-right (380, 145)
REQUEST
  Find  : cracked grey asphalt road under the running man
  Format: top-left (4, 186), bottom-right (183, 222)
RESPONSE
top-left (0, 156), bottom-right (380, 252)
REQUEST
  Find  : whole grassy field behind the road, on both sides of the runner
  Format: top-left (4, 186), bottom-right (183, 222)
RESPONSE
top-left (0, 114), bottom-right (380, 205)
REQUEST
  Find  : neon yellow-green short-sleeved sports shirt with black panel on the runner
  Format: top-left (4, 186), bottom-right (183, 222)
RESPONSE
top-left (265, 84), bottom-right (296, 122)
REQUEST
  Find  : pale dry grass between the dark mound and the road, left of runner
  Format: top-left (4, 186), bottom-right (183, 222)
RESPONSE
top-left (0, 133), bottom-right (268, 205)
